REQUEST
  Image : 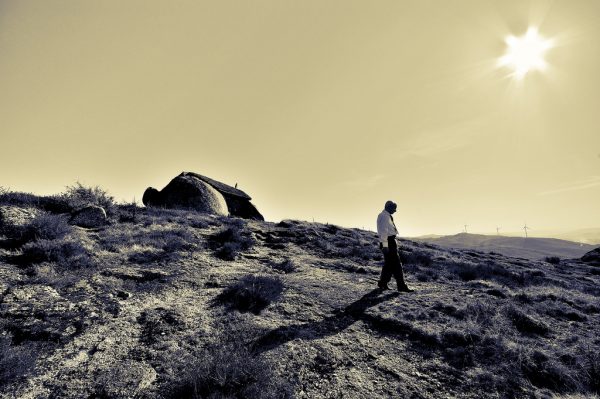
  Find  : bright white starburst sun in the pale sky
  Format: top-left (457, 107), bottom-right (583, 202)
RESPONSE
top-left (498, 27), bottom-right (553, 80)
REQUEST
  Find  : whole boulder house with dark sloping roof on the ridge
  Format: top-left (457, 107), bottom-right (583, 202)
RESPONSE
top-left (142, 172), bottom-right (264, 220)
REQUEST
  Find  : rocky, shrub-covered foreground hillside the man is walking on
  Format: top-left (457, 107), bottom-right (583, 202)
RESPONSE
top-left (0, 189), bottom-right (600, 399)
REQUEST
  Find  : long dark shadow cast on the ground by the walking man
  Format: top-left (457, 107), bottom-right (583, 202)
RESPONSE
top-left (251, 289), bottom-right (398, 353)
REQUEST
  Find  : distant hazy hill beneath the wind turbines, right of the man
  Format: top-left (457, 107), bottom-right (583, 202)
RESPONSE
top-left (412, 233), bottom-right (596, 260)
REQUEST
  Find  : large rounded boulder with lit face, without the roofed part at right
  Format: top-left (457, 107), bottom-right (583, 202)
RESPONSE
top-left (142, 174), bottom-right (229, 215)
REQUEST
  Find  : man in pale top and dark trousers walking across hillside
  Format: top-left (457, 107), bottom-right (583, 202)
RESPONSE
top-left (377, 201), bottom-right (413, 292)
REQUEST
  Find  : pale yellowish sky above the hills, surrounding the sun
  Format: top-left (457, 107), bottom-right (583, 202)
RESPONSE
top-left (0, 0), bottom-right (600, 235)
